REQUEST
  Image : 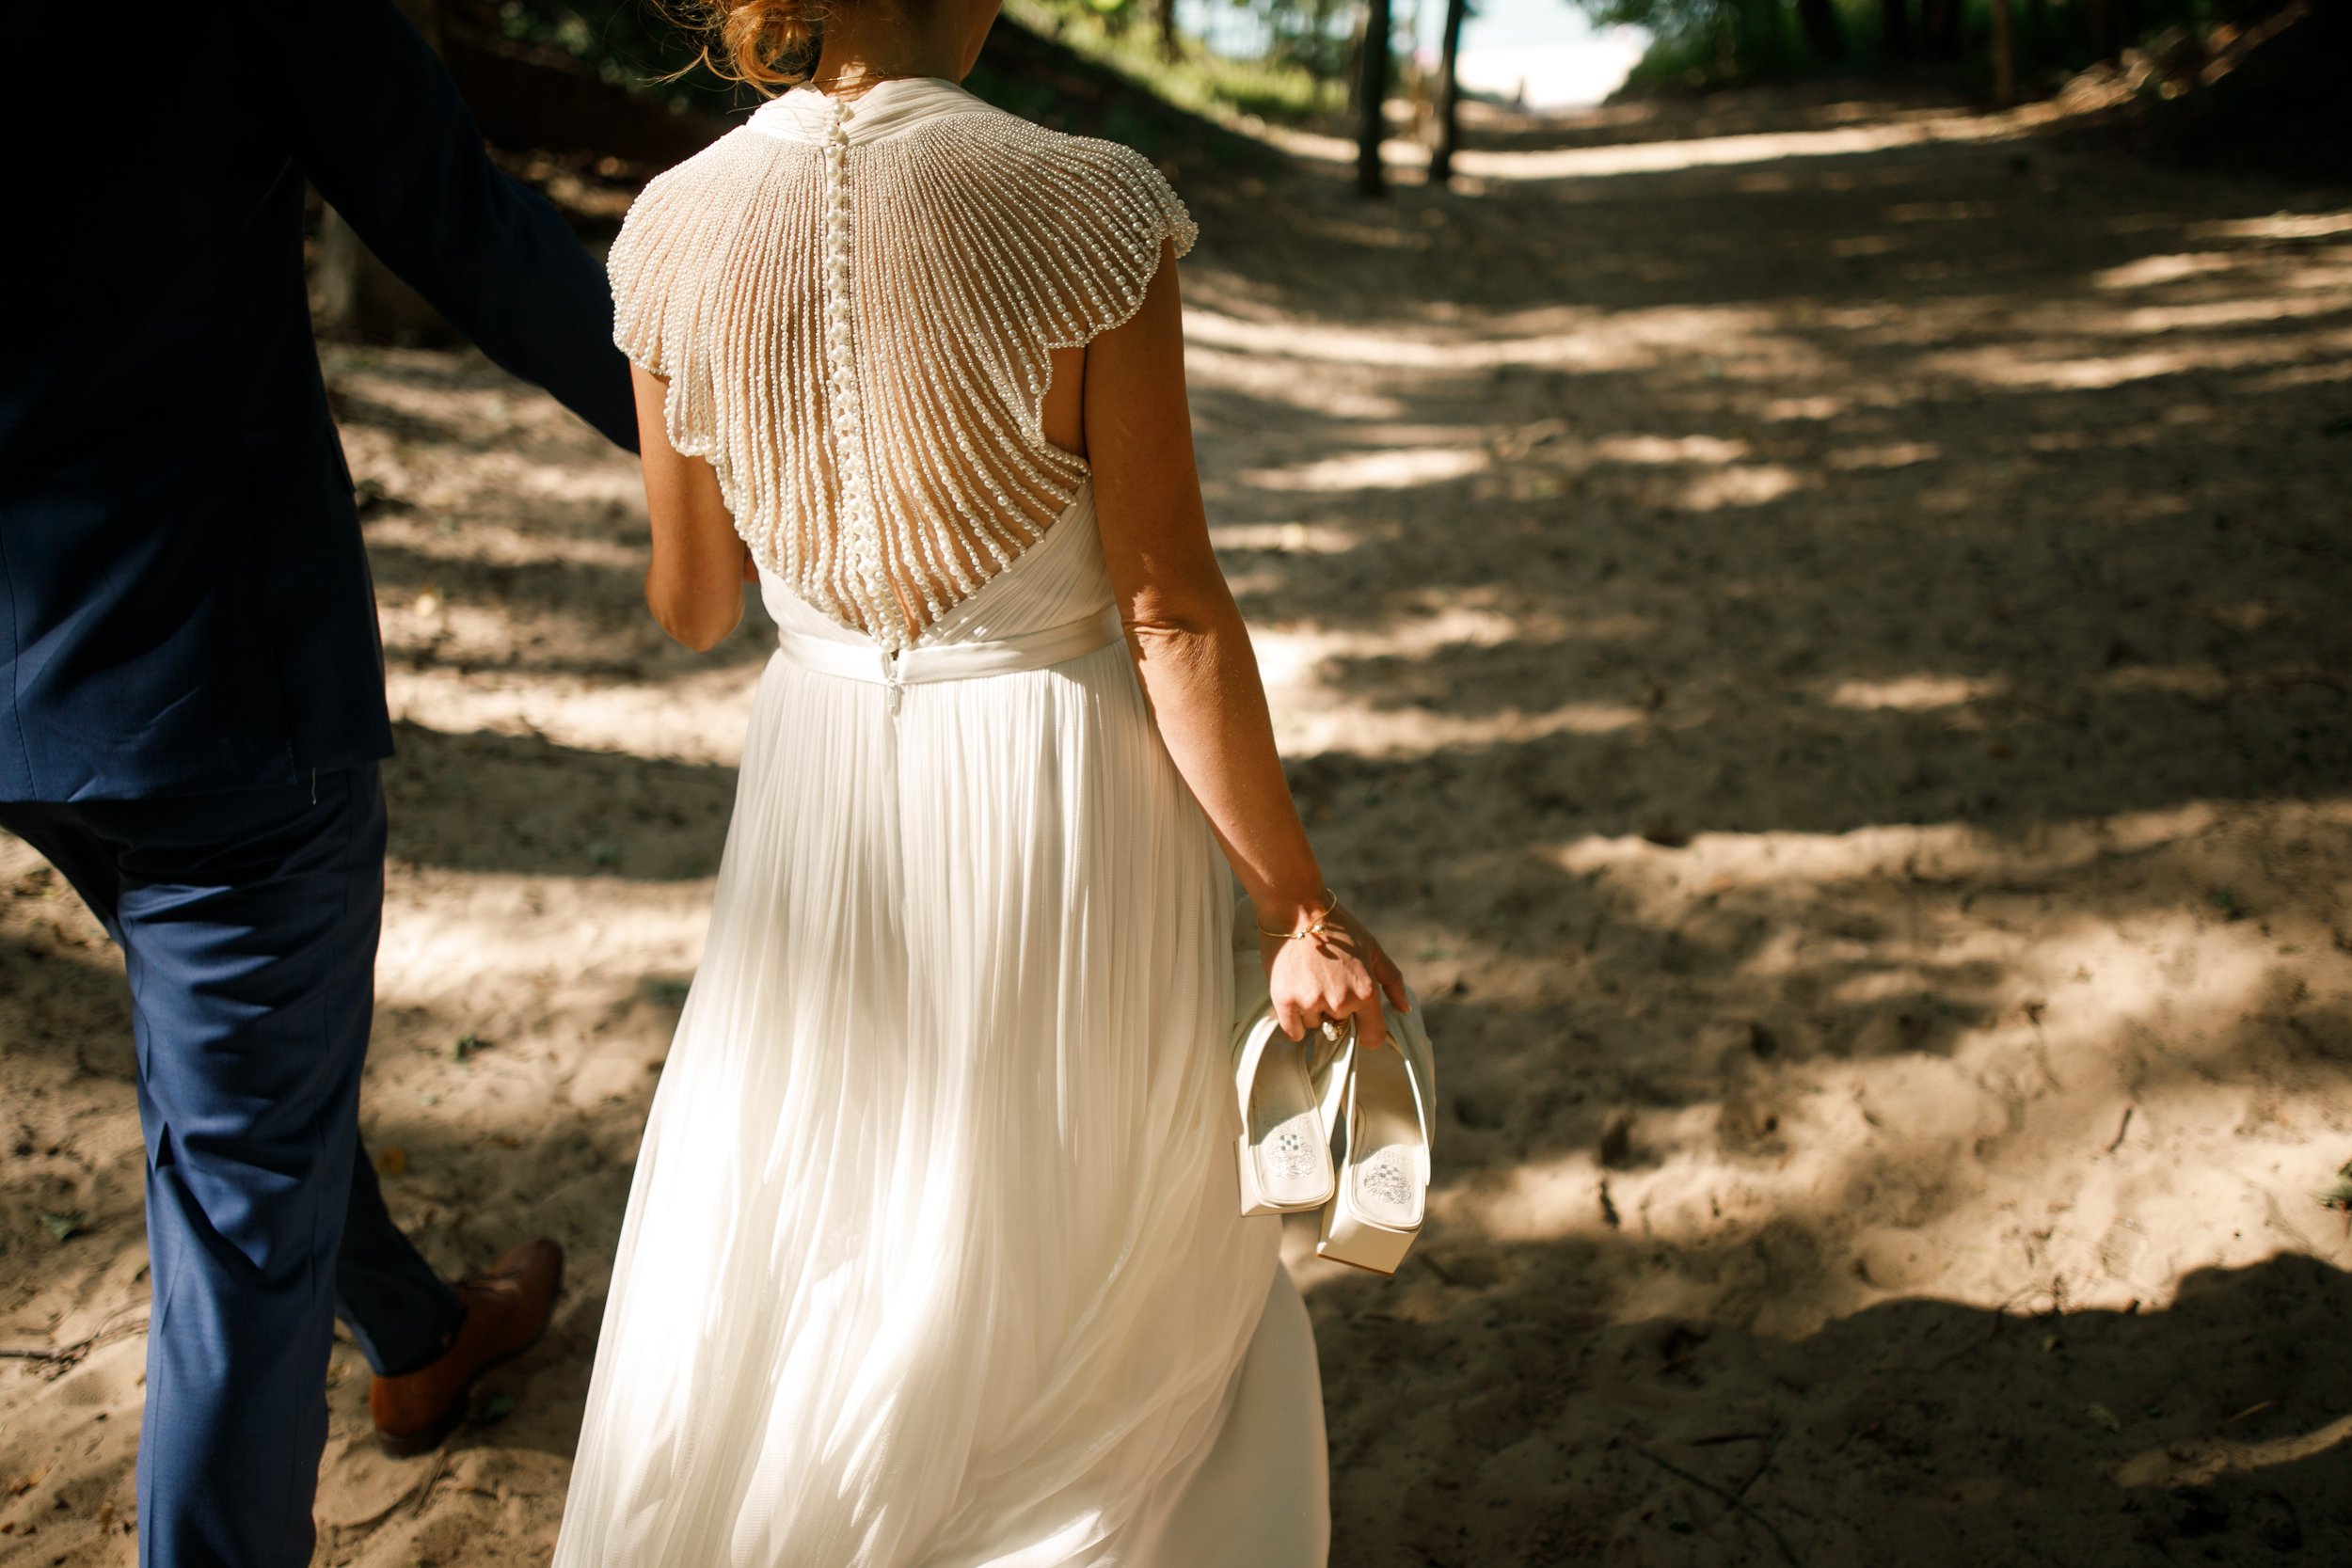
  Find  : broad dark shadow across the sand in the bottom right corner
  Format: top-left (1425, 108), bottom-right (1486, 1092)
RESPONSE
top-left (1312, 1232), bottom-right (2352, 1568)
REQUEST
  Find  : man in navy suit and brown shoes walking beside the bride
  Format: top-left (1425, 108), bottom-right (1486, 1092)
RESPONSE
top-left (0, 0), bottom-right (635, 1568)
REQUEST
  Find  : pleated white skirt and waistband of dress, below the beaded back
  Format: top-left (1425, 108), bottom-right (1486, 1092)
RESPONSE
top-left (555, 491), bottom-right (1329, 1568)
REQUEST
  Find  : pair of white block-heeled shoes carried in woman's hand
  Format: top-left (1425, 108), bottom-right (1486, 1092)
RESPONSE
top-left (1232, 930), bottom-right (1438, 1275)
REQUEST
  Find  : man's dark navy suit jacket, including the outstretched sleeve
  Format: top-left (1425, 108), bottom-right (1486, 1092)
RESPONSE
top-left (0, 0), bottom-right (638, 801)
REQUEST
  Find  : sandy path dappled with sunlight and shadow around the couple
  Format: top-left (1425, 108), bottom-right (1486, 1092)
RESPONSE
top-left (0, 79), bottom-right (2352, 1568)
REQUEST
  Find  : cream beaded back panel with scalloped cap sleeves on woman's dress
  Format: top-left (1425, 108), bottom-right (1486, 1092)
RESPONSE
top-left (610, 82), bottom-right (1195, 649)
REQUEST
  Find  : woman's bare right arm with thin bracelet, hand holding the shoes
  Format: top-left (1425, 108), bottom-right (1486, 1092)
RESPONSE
top-left (1085, 251), bottom-right (1405, 1044)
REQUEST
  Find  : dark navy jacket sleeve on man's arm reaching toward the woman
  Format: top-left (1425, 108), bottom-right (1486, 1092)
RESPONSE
top-left (230, 0), bottom-right (638, 451)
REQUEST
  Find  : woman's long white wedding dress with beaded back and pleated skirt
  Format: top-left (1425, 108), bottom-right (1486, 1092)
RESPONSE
top-left (555, 80), bottom-right (1329, 1568)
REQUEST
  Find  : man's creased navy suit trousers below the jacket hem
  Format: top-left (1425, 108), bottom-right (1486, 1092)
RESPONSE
top-left (0, 764), bottom-right (464, 1568)
